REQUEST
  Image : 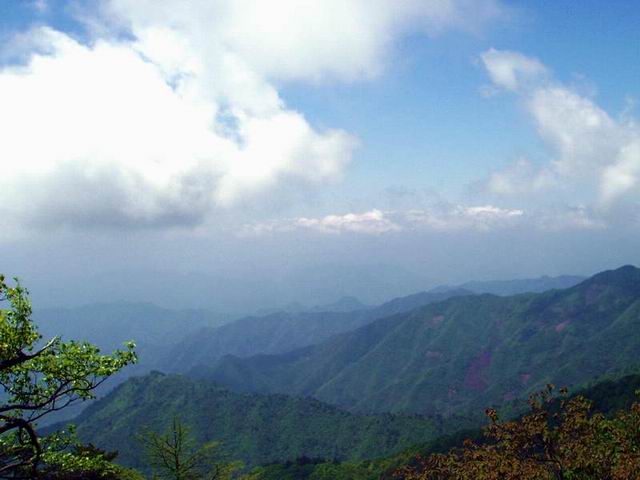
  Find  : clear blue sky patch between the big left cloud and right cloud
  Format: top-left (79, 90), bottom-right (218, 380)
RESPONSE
top-left (283, 1), bottom-right (640, 199)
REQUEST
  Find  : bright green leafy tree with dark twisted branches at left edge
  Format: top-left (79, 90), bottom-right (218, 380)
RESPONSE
top-left (0, 275), bottom-right (136, 478)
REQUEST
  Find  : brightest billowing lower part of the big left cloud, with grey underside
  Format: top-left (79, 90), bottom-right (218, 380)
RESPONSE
top-left (0, 29), bottom-right (354, 231)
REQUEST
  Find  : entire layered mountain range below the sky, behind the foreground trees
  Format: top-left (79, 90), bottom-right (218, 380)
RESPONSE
top-left (47, 266), bottom-right (640, 479)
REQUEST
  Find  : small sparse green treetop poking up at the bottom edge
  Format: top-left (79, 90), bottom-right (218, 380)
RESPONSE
top-left (139, 417), bottom-right (241, 480)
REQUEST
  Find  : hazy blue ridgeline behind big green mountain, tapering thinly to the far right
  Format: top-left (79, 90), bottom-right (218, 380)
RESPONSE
top-left (155, 276), bottom-right (582, 372)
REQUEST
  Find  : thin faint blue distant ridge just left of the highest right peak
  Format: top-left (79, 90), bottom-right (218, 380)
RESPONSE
top-left (430, 275), bottom-right (586, 296)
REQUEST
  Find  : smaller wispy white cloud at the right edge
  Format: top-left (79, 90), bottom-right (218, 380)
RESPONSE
top-left (482, 49), bottom-right (640, 209)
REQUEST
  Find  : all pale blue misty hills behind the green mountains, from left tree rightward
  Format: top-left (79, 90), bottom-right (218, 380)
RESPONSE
top-left (34, 276), bottom-right (592, 378)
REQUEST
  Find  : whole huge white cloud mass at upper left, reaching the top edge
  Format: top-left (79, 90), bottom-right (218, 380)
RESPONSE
top-left (0, 0), bottom-right (503, 232)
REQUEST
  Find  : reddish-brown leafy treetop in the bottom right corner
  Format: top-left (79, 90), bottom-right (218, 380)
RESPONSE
top-left (397, 385), bottom-right (640, 480)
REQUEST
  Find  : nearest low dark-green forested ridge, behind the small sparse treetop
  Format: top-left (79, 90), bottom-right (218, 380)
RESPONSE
top-left (63, 372), bottom-right (455, 467)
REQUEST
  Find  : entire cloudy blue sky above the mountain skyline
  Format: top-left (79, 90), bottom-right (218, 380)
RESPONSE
top-left (0, 0), bottom-right (640, 311)
